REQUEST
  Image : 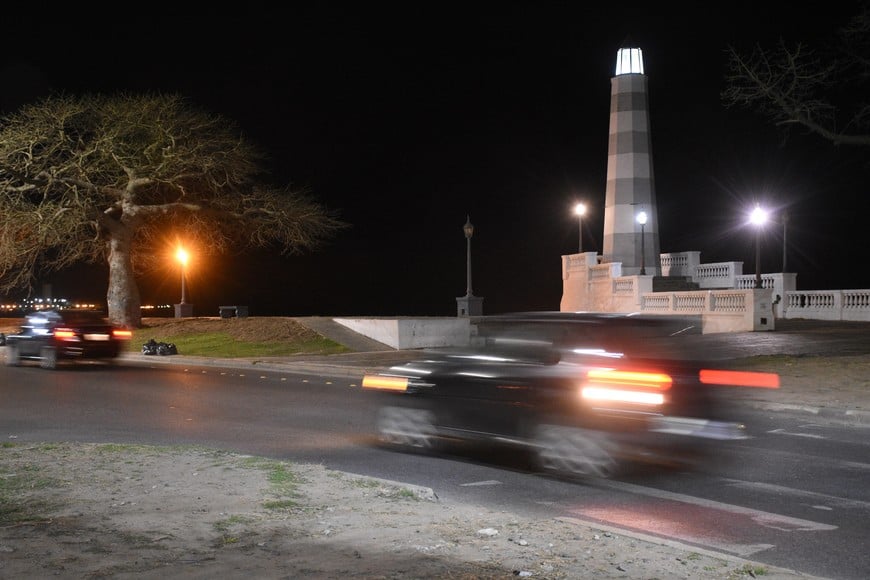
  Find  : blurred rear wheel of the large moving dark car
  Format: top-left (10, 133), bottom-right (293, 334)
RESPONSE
top-left (534, 425), bottom-right (618, 478)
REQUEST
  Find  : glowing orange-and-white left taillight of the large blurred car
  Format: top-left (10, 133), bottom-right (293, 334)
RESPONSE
top-left (580, 369), bottom-right (674, 405)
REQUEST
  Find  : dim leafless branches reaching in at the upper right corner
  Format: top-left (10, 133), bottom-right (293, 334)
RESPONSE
top-left (722, 4), bottom-right (870, 145)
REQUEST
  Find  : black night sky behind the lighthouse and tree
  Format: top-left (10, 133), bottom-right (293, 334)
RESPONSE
top-left (0, 2), bottom-right (870, 316)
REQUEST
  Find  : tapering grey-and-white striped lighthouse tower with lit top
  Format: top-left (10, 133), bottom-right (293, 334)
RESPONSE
top-left (602, 48), bottom-right (661, 276)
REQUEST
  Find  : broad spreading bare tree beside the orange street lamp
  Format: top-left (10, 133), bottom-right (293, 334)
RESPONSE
top-left (0, 94), bottom-right (347, 327)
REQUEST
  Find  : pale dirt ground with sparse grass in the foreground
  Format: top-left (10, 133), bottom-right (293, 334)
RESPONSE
top-left (0, 442), bottom-right (816, 579)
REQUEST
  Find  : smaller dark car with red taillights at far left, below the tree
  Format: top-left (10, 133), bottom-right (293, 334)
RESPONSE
top-left (6, 309), bottom-right (132, 369)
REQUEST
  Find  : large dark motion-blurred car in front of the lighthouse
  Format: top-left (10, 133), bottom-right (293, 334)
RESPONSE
top-left (362, 312), bottom-right (779, 477)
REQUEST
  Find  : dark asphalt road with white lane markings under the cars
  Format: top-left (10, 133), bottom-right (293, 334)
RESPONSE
top-left (0, 364), bottom-right (870, 579)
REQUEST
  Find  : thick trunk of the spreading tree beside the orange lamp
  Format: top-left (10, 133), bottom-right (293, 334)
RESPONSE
top-left (106, 231), bottom-right (142, 328)
